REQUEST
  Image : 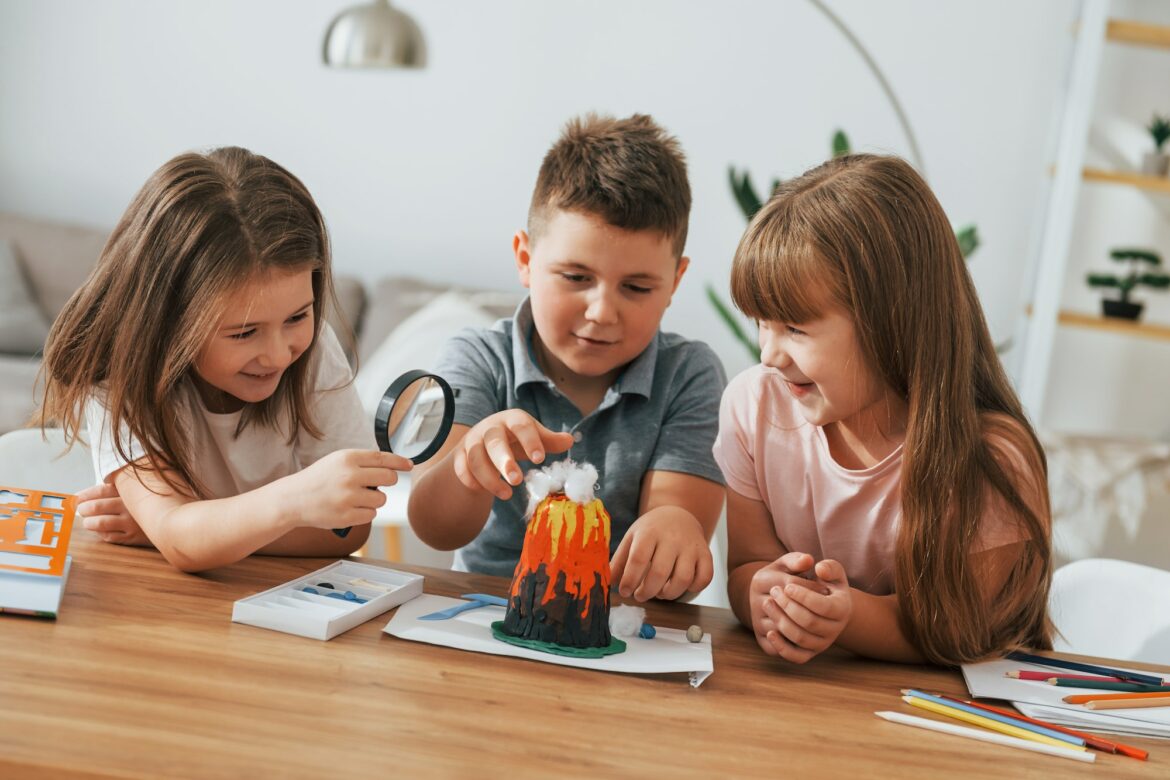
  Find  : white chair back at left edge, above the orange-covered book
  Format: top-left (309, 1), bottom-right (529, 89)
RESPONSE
top-left (0, 428), bottom-right (96, 492)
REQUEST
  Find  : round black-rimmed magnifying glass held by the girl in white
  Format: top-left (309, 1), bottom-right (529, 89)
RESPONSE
top-left (333, 370), bottom-right (455, 538)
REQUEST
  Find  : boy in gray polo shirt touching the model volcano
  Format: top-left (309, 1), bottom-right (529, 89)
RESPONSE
top-left (408, 115), bottom-right (727, 601)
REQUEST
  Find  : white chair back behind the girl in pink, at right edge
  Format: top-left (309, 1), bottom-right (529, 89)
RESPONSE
top-left (1048, 558), bottom-right (1170, 665)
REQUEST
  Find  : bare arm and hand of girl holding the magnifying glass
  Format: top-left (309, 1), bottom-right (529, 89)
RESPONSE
top-left (113, 450), bottom-right (411, 572)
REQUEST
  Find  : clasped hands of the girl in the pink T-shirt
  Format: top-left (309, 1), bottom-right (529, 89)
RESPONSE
top-left (757, 553), bottom-right (853, 663)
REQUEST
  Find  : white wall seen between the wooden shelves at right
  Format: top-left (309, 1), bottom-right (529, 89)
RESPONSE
top-left (1042, 0), bottom-right (1170, 440)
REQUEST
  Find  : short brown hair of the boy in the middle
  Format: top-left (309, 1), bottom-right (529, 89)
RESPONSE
top-left (528, 113), bottom-right (690, 256)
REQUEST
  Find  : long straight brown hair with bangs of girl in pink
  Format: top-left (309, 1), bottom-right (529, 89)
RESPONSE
top-left (731, 154), bottom-right (1052, 664)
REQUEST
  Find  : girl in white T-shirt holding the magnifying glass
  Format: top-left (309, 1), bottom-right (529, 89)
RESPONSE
top-left (41, 147), bottom-right (411, 571)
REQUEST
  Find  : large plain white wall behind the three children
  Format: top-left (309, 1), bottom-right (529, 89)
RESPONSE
top-left (0, 0), bottom-right (1076, 383)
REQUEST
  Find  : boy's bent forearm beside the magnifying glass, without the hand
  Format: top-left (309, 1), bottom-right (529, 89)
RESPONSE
top-left (406, 423), bottom-right (494, 550)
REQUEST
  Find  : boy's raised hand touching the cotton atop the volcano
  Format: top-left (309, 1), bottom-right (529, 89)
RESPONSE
top-left (454, 409), bottom-right (573, 501)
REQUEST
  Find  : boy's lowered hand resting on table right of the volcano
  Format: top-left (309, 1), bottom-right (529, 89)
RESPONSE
top-left (610, 506), bottom-right (714, 601)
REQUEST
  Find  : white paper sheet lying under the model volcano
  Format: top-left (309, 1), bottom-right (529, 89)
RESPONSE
top-left (383, 593), bottom-right (715, 688)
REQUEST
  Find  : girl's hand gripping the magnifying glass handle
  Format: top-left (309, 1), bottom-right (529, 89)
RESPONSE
top-left (281, 449), bottom-right (413, 529)
